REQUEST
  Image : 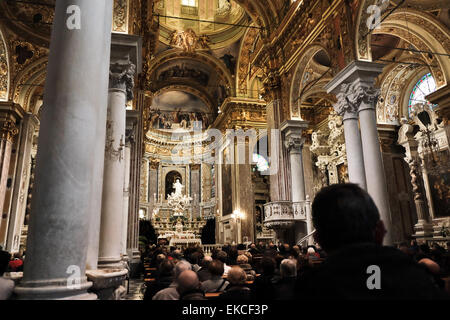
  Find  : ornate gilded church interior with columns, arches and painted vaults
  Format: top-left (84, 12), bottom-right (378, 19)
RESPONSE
top-left (0, 0), bottom-right (450, 300)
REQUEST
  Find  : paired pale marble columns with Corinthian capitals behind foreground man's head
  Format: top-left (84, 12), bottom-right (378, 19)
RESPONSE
top-left (325, 61), bottom-right (392, 245)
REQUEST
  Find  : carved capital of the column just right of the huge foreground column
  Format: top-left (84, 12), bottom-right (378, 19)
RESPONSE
top-left (109, 62), bottom-right (136, 101)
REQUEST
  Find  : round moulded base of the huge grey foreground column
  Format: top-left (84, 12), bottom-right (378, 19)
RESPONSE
top-left (14, 278), bottom-right (97, 300)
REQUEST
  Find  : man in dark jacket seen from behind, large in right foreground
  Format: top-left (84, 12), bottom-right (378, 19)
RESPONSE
top-left (296, 184), bottom-right (446, 300)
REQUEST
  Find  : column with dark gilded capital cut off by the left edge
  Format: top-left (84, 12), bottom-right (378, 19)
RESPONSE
top-left (0, 102), bottom-right (23, 246)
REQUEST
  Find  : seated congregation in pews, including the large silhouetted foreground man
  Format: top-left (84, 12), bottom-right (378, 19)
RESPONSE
top-left (144, 184), bottom-right (450, 301)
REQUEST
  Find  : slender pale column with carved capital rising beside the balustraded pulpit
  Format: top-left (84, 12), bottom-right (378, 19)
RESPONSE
top-left (281, 120), bottom-right (312, 243)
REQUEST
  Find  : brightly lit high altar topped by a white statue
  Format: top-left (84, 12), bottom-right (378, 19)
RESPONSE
top-left (152, 179), bottom-right (206, 246)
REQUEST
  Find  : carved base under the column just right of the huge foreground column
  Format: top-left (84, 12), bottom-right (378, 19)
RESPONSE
top-left (86, 269), bottom-right (128, 300)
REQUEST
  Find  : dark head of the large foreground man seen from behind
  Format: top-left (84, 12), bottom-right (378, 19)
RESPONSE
top-left (312, 183), bottom-right (385, 252)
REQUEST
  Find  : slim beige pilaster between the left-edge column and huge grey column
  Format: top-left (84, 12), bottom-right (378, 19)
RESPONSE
top-left (6, 113), bottom-right (39, 253)
